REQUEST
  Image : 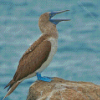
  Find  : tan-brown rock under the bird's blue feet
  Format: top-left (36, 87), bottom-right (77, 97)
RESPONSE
top-left (27, 78), bottom-right (100, 100)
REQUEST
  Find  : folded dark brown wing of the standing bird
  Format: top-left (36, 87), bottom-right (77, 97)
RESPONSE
top-left (13, 34), bottom-right (51, 81)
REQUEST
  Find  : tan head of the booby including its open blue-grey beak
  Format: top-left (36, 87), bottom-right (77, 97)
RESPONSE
top-left (38, 10), bottom-right (70, 33)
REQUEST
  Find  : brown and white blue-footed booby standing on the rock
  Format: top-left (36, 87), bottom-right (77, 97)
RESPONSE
top-left (3, 10), bottom-right (70, 100)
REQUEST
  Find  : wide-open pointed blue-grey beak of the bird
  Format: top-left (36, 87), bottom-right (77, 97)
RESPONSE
top-left (50, 10), bottom-right (70, 25)
